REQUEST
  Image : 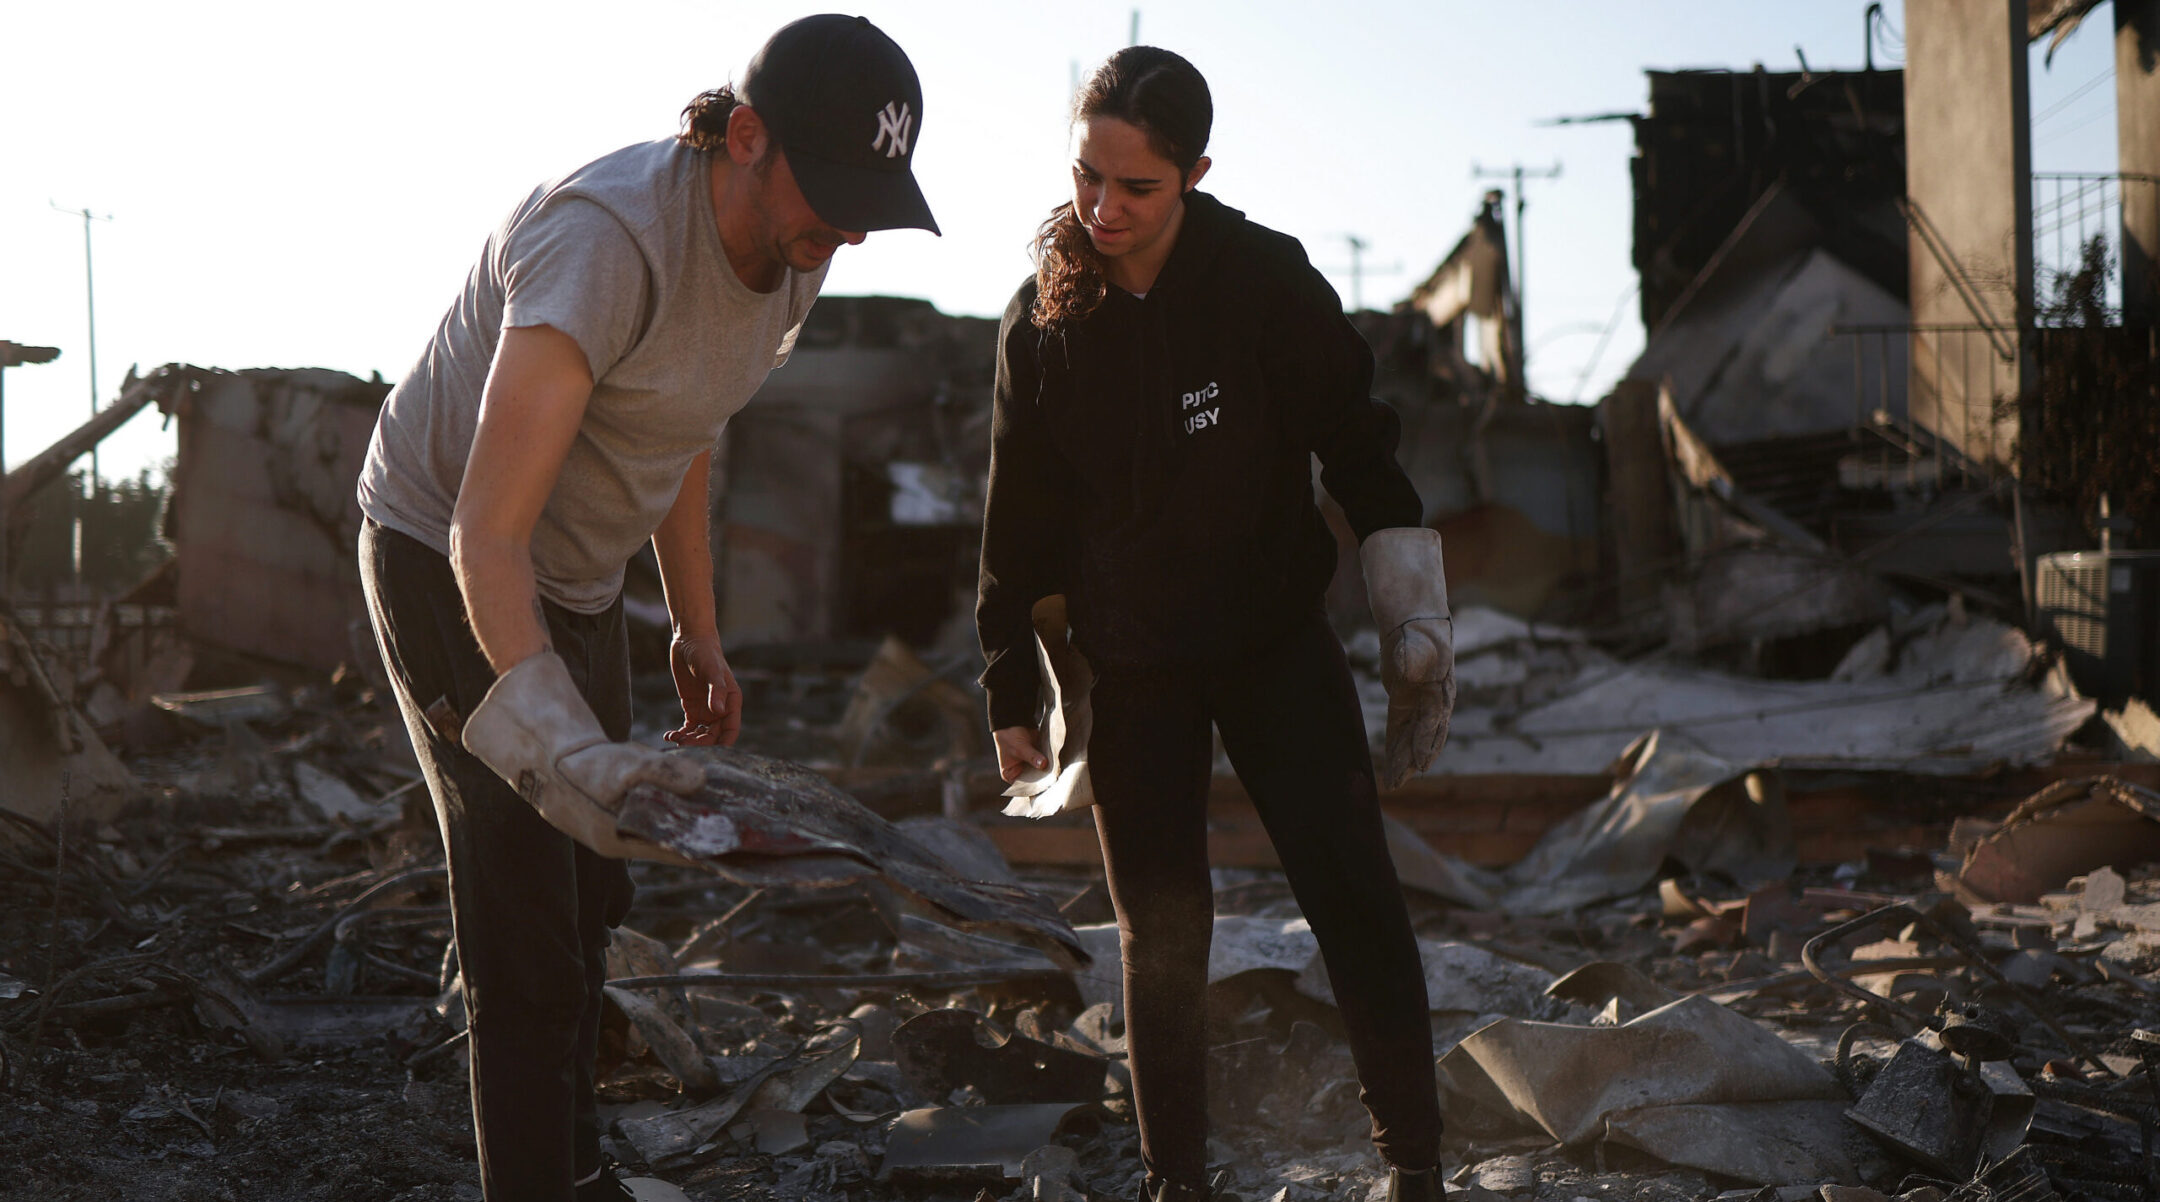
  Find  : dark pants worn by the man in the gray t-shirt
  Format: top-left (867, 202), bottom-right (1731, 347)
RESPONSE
top-left (361, 521), bottom-right (631, 1202)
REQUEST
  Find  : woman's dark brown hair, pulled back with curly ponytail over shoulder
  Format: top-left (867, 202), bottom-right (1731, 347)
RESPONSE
top-left (1028, 45), bottom-right (1214, 331)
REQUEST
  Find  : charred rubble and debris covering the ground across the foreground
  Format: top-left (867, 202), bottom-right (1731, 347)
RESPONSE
top-left (0, 618), bottom-right (2160, 1202)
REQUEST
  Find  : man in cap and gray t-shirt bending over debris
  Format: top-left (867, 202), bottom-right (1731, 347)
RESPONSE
top-left (359, 15), bottom-right (937, 1202)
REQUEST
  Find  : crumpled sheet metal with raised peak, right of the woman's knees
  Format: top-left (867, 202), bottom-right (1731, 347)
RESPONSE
top-left (1417, 731), bottom-right (1795, 914)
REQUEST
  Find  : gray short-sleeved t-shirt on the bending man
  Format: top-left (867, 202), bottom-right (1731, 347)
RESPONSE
top-left (361, 138), bottom-right (825, 614)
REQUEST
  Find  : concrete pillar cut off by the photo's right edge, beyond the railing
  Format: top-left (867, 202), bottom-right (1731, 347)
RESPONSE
top-left (2115, 0), bottom-right (2160, 324)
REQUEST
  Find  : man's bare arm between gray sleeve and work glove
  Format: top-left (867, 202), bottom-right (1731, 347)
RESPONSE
top-left (449, 326), bottom-right (592, 675)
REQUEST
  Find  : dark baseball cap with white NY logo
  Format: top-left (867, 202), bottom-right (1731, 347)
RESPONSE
top-left (741, 13), bottom-right (937, 233)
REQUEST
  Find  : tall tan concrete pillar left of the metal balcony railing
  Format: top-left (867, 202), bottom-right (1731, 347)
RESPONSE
top-left (1905, 0), bottom-right (2033, 467)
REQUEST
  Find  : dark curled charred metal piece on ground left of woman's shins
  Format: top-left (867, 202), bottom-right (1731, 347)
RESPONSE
top-left (892, 1010), bottom-right (1104, 1105)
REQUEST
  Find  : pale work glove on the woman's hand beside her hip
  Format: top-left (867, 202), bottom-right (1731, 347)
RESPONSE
top-left (1359, 525), bottom-right (1456, 789)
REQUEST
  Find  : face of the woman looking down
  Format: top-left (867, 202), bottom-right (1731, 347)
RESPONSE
top-left (1074, 117), bottom-right (1207, 264)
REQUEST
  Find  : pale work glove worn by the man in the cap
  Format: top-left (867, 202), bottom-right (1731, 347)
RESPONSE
top-left (464, 651), bottom-right (704, 865)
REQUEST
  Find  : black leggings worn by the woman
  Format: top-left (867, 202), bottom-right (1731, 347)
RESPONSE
top-left (1089, 614), bottom-right (1441, 1185)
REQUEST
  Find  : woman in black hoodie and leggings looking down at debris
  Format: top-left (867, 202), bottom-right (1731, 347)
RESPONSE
top-left (976, 45), bottom-right (1454, 1202)
